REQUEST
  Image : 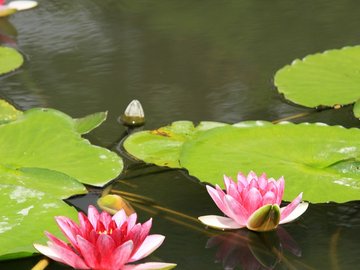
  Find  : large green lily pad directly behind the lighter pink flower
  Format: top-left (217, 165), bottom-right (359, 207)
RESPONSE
top-left (180, 122), bottom-right (360, 202)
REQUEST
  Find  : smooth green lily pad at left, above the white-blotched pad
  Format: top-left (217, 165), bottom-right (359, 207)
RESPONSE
top-left (0, 109), bottom-right (123, 186)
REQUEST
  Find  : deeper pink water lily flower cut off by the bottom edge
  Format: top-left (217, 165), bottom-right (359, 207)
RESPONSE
top-left (34, 206), bottom-right (176, 270)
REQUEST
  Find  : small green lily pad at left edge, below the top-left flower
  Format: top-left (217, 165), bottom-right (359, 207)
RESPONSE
top-left (0, 46), bottom-right (24, 75)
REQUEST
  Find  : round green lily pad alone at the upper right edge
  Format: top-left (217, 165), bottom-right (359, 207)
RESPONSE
top-left (275, 46), bottom-right (360, 117)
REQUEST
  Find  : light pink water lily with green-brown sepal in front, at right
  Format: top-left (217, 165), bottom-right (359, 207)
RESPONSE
top-left (199, 172), bottom-right (308, 231)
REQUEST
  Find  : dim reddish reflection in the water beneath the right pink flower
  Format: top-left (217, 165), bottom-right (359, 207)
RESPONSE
top-left (206, 227), bottom-right (301, 270)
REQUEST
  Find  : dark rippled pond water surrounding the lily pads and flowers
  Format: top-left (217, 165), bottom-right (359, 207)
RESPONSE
top-left (0, 0), bottom-right (360, 269)
